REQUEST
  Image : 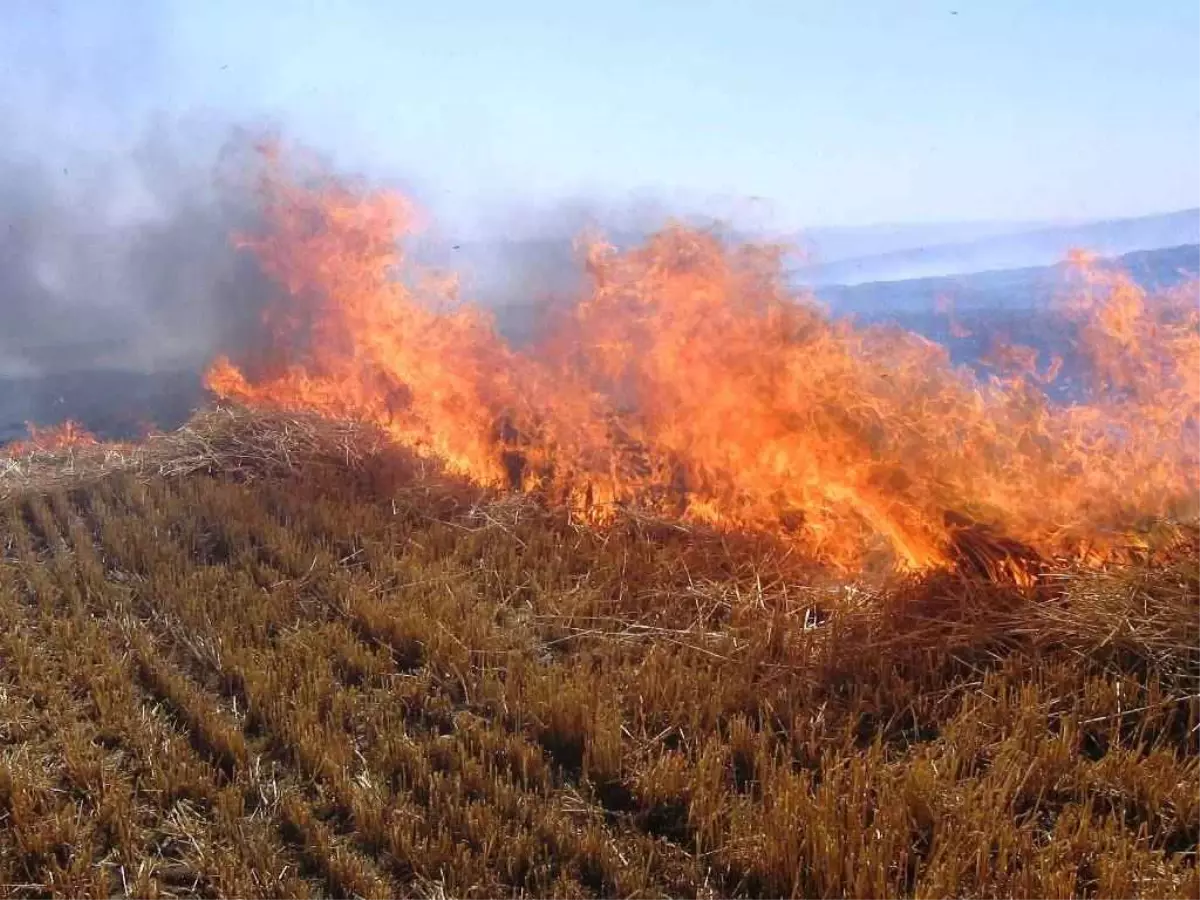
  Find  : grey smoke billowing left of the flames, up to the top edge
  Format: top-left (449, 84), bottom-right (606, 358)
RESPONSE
top-left (0, 0), bottom-right (285, 442)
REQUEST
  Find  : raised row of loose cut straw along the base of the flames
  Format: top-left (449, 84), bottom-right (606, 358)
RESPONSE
top-left (7, 404), bottom-right (1200, 676)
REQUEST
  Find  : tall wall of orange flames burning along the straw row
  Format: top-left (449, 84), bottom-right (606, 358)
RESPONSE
top-left (208, 147), bottom-right (1200, 569)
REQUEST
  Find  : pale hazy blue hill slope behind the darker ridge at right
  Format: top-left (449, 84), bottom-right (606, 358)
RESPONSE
top-left (794, 209), bottom-right (1200, 286)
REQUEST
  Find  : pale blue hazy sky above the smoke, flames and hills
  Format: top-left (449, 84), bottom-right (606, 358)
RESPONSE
top-left (7, 0), bottom-right (1200, 226)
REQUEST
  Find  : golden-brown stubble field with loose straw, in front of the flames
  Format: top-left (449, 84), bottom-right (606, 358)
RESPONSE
top-left (0, 413), bottom-right (1200, 898)
